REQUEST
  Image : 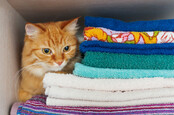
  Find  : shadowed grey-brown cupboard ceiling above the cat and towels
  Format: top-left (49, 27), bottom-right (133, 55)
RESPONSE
top-left (8, 0), bottom-right (174, 22)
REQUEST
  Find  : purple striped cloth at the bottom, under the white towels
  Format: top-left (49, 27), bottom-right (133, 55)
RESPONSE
top-left (17, 95), bottom-right (174, 115)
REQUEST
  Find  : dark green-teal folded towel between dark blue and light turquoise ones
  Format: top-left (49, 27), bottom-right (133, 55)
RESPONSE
top-left (82, 52), bottom-right (174, 70)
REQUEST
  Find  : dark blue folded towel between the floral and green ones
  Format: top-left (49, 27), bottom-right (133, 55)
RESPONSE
top-left (80, 41), bottom-right (174, 55)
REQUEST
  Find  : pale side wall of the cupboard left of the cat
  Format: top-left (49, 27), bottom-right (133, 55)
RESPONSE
top-left (0, 0), bottom-right (25, 115)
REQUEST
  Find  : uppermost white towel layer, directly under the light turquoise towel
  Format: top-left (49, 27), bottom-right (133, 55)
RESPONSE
top-left (43, 73), bottom-right (174, 91)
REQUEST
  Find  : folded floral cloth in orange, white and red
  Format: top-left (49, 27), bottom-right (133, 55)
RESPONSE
top-left (84, 27), bottom-right (174, 44)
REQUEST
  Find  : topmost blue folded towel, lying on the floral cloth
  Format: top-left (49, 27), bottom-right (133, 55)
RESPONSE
top-left (85, 16), bottom-right (174, 32)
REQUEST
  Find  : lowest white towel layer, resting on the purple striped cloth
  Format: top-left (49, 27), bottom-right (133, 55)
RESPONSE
top-left (46, 96), bottom-right (174, 107)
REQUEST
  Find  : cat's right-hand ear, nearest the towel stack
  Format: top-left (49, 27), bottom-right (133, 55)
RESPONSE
top-left (62, 17), bottom-right (79, 35)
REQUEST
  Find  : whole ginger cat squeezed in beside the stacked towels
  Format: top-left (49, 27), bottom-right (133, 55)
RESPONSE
top-left (18, 18), bottom-right (80, 102)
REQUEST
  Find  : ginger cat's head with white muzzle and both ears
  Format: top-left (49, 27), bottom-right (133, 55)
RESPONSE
top-left (22, 19), bottom-right (78, 76)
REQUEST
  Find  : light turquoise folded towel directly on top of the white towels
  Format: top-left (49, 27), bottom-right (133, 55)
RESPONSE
top-left (73, 63), bottom-right (174, 79)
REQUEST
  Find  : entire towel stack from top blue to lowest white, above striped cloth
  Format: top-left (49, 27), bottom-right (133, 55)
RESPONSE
top-left (43, 17), bottom-right (174, 107)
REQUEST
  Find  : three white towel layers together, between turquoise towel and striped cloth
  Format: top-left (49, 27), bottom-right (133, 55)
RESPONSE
top-left (44, 73), bottom-right (174, 107)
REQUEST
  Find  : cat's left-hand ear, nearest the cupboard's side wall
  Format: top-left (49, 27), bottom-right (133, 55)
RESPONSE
top-left (25, 23), bottom-right (42, 36)
